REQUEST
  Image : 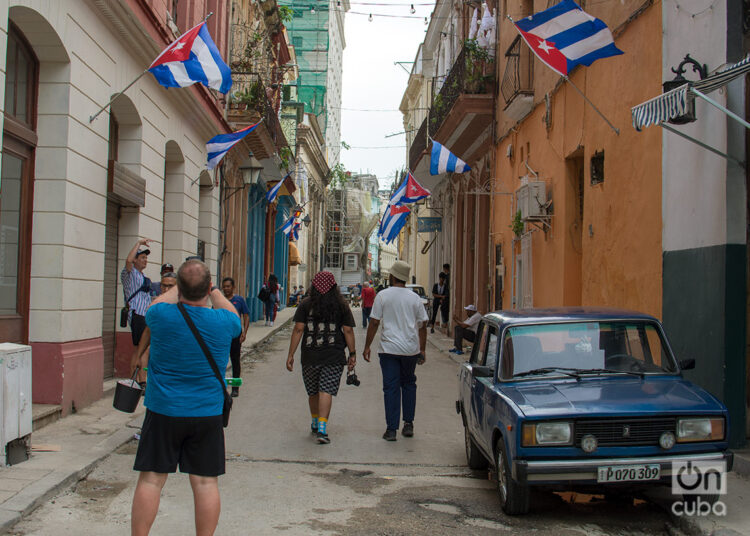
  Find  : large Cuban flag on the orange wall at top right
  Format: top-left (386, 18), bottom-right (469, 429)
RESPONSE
top-left (513, 0), bottom-right (623, 76)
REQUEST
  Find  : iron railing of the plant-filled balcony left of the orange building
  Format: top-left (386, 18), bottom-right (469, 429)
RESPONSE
top-left (409, 45), bottom-right (495, 167)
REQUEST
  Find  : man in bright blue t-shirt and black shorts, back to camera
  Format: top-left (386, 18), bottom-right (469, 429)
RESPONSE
top-left (131, 260), bottom-right (242, 534)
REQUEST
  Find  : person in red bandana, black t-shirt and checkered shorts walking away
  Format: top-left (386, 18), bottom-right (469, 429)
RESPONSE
top-left (286, 272), bottom-right (357, 444)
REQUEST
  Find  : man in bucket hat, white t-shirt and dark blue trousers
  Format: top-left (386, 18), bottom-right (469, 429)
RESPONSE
top-left (362, 261), bottom-right (429, 441)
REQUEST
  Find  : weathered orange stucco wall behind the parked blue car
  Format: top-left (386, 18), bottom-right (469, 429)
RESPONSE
top-left (493, 2), bottom-right (662, 316)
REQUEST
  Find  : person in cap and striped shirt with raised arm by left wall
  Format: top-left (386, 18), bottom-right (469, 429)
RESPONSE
top-left (120, 238), bottom-right (151, 382)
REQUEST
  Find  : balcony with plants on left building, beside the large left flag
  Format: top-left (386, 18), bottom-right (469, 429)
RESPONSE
top-left (227, 72), bottom-right (289, 160)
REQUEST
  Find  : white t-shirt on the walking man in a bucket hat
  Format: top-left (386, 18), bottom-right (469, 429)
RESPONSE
top-left (370, 287), bottom-right (429, 355)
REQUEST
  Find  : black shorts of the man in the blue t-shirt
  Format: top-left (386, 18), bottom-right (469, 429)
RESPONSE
top-left (133, 410), bottom-right (226, 476)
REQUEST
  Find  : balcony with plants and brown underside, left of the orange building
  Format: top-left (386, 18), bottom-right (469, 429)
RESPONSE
top-left (409, 42), bottom-right (495, 174)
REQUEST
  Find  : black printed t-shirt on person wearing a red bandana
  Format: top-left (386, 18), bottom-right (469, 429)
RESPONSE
top-left (294, 298), bottom-right (354, 365)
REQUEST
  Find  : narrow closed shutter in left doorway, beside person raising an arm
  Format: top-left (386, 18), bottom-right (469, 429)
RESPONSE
top-left (102, 201), bottom-right (120, 378)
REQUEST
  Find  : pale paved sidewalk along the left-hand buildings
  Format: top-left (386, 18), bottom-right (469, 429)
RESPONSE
top-left (0, 308), bottom-right (296, 534)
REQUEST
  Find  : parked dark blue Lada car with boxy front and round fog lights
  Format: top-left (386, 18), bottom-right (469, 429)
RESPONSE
top-left (456, 308), bottom-right (732, 514)
